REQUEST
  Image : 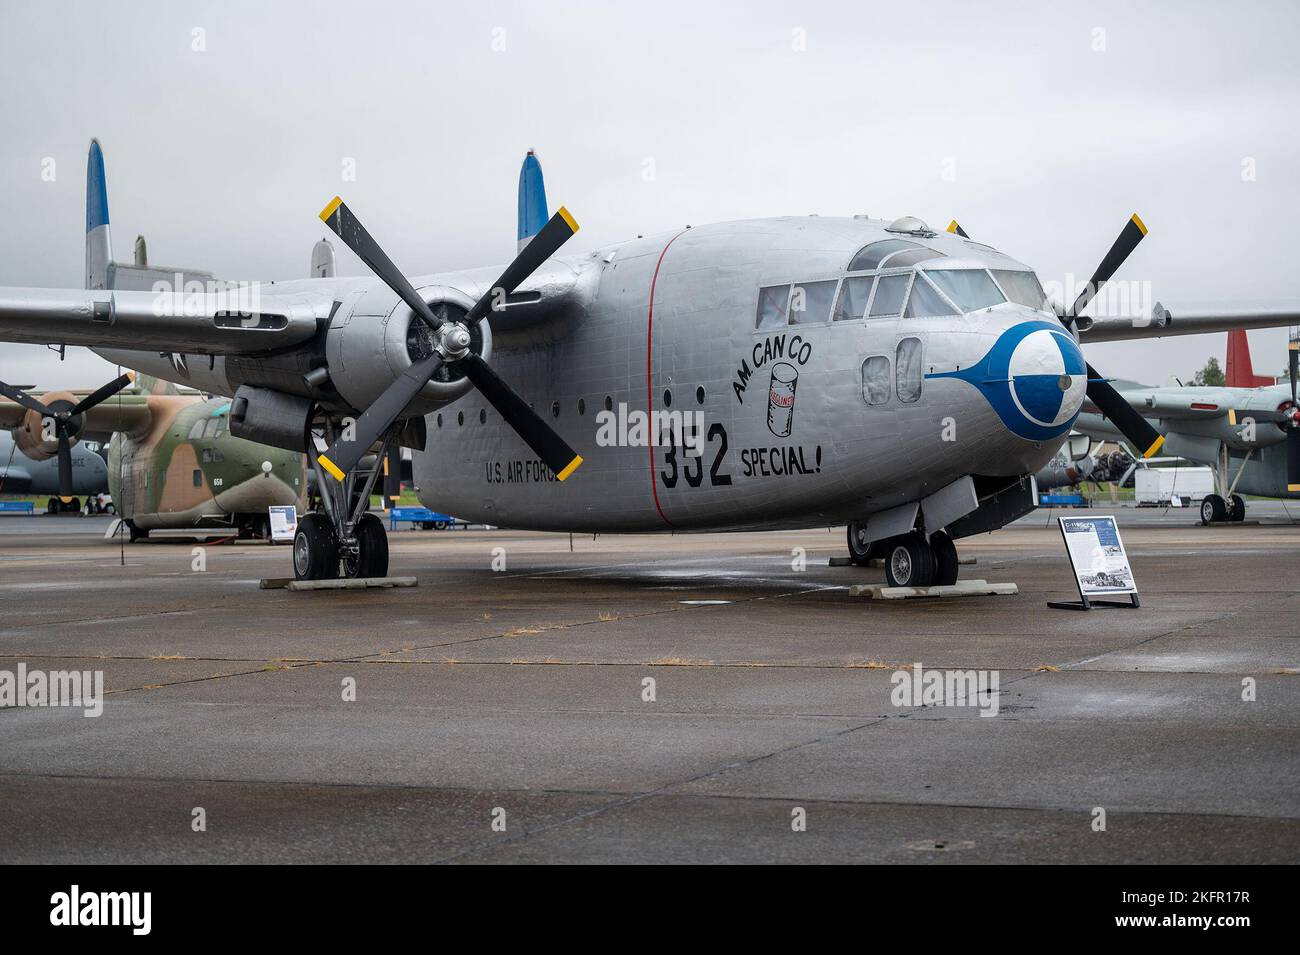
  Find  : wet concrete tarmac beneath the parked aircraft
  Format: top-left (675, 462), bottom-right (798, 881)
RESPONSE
top-left (0, 502), bottom-right (1300, 864)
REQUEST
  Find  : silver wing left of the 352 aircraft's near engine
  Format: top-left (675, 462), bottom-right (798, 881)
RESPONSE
top-left (0, 286), bottom-right (334, 355)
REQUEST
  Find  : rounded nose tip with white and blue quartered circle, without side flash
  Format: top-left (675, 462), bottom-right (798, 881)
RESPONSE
top-left (1008, 324), bottom-right (1088, 427)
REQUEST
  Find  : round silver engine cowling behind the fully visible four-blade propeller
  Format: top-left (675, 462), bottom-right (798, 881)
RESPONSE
top-left (325, 286), bottom-right (491, 414)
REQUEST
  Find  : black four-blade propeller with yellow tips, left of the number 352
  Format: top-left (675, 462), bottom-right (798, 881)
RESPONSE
top-left (317, 196), bottom-right (582, 481)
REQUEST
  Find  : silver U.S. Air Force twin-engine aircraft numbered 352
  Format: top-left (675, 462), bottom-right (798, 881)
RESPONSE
top-left (0, 143), bottom-right (1300, 586)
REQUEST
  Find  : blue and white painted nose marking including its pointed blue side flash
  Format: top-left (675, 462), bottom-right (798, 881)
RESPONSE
top-left (926, 322), bottom-right (1088, 440)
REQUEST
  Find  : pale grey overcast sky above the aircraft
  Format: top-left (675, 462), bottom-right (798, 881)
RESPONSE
top-left (0, 0), bottom-right (1300, 387)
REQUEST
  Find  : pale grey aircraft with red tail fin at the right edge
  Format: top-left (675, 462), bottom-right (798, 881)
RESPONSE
top-left (1075, 330), bottom-right (1300, 524)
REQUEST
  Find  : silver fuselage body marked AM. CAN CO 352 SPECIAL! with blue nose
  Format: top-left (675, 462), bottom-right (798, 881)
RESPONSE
top-left (98, 217), bottom-right (1087, 531)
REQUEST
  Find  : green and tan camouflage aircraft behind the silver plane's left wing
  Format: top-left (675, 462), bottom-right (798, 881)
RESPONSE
top-left (0, 376), bottom-right (307, 542)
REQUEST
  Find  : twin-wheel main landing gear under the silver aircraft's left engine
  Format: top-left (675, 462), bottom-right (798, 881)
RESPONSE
top-left (294, 422), bottom-right (393, 581)
